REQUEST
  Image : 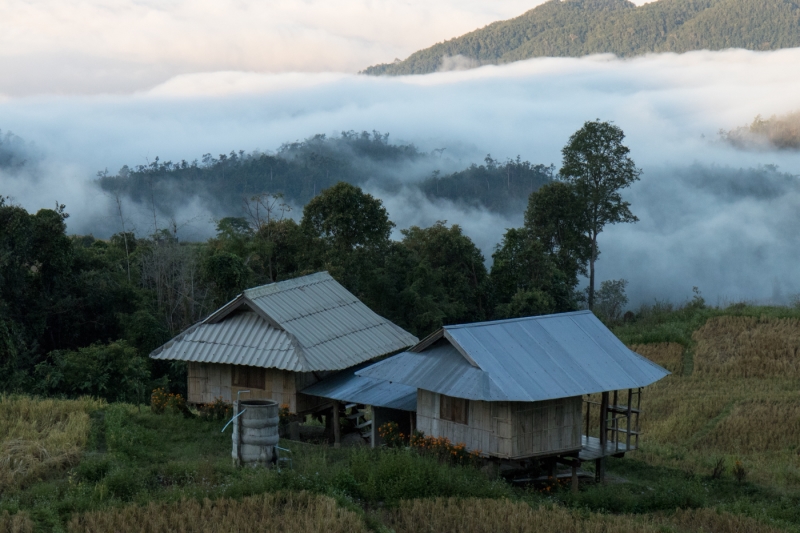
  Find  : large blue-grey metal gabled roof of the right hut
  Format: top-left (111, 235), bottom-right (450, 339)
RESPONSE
top-left (356, 311), bottom-right (669, 402)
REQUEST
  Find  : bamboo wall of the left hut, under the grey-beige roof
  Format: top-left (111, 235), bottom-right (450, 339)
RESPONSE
top-left (187, 362), bottom-right (326, 413)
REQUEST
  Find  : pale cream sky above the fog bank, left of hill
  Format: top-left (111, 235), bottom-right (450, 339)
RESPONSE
top-left (0, 0), bottom-right (541, 96)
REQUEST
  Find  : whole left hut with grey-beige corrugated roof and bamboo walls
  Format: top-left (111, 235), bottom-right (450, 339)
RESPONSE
top-left (150, 272), bottom-right (417, 414)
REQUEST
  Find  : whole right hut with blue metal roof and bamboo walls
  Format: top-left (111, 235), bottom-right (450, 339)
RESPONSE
top-left (356, 311), bottom-right (669, 480)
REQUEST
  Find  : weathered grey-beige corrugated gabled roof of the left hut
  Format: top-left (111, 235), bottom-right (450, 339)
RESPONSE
top-left (150, 272), bottom-right (417, 372)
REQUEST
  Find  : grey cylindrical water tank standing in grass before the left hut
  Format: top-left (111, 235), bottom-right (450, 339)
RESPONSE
top-left (231, 400), bottom-right (280, 466)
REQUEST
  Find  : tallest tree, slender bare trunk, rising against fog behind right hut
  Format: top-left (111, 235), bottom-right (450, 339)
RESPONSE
top-left (559, 119), bottom-right (642, 309)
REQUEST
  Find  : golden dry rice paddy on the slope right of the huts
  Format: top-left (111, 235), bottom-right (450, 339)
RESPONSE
top-left (632, 317), bottom-right (800, 486)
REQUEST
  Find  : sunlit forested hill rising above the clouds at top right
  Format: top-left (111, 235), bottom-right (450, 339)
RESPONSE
top-left (363, 0), bottom-right (800, 75)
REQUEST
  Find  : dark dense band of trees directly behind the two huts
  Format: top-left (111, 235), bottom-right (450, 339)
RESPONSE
top-left (0, 182), bottom-right (583, 401)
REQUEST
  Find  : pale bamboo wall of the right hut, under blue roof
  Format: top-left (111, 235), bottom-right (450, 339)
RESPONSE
top-left (417, 389), bottom-right (582, 459)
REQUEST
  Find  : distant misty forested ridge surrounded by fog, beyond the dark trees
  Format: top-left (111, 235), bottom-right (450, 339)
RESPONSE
top-left (98, 131), bottom-right (553, 215)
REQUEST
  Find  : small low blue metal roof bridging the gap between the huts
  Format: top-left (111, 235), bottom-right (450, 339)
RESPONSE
top-left (301, 363), bottom-right (417, 411)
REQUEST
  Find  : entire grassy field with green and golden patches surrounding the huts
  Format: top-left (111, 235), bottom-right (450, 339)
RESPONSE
top-left (0, 304), bottom-right (800, 533)
